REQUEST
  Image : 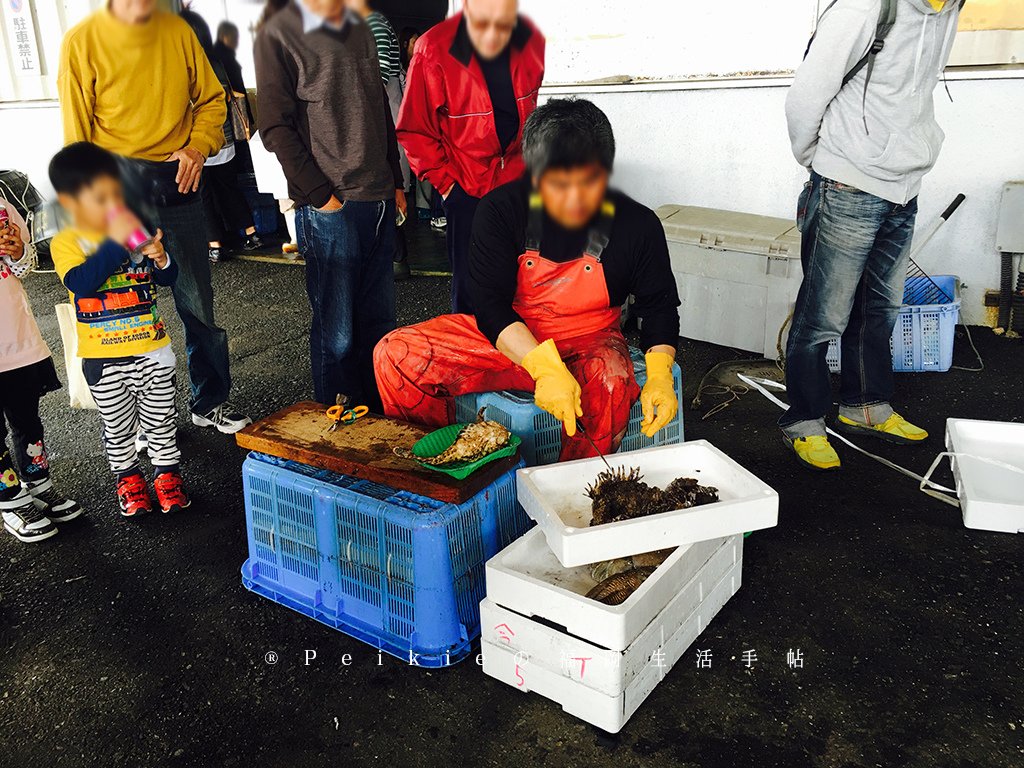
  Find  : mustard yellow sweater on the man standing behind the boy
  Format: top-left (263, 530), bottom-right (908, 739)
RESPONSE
top-left (57, 8), bottom-right (227, 161)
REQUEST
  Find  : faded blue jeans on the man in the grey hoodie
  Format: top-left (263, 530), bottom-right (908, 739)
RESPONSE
top-left (779, 173), bottom-right (918, 438)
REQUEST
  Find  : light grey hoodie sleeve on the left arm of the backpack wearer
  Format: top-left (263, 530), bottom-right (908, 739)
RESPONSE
top-left (785, 5), bottom-right (878, 168)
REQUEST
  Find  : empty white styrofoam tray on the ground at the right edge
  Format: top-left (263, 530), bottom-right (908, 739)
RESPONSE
top-left (946, 419), bottom-right (1024, 534)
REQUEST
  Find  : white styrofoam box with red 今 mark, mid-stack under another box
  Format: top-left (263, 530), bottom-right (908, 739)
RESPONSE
top-left (480, 537), bottom-right (742, 696)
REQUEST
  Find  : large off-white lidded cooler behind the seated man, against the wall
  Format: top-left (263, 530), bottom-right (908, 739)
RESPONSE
top-left (657, 201), bottom-right (803, 359)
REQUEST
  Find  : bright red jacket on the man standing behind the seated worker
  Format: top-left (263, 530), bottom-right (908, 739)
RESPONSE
top-left (397, 13), bottom-right (544, 198)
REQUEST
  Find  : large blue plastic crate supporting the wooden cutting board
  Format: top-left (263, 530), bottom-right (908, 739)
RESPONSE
top-left (242, 454), bottom-right (531, 667)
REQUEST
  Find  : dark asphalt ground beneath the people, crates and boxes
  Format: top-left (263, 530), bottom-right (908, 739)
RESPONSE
top-left (0, 256), bottom-right (1024, 768)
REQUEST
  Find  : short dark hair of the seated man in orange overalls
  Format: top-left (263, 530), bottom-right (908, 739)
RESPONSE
top-left (522, 98), bottom-right (615, 176)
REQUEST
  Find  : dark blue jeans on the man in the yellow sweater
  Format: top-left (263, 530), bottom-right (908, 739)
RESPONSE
top-left (153, 195), bottom-right (231, 414)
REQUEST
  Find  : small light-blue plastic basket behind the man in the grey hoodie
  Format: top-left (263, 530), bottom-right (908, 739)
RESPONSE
top-left (825, 274), bottom-right (961, 373)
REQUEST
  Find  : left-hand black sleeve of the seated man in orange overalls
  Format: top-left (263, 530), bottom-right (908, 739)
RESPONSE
top-left (468, 189), bottom-right (523, 344)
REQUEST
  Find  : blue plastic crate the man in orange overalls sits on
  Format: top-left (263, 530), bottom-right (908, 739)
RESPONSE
top-left (455, 349), bottom-right (683, 467)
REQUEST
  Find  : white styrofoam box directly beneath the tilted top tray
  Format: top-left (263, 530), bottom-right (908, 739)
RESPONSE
top-left (483, 527), bottom-right (724, 650)
